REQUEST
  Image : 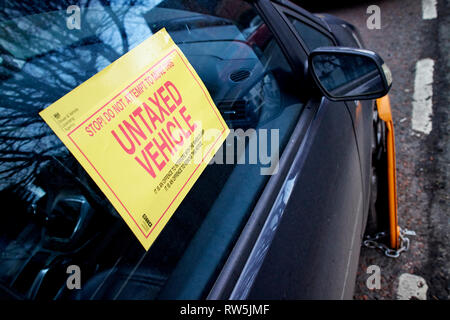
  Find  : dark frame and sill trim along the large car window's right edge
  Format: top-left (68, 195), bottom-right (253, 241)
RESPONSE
top-left (207, 0), bottom-right (366, 299)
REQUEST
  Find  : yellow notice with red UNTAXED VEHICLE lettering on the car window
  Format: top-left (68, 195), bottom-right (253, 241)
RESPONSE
top-left (40, 29), bottom-right (229, 250)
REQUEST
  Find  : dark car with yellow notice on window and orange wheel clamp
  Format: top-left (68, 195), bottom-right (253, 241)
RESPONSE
top-left (0, 0), bottom-right (401, 300)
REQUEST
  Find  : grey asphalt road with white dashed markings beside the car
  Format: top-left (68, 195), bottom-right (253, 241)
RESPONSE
top-left (304, 0), bottom-right (450, 300)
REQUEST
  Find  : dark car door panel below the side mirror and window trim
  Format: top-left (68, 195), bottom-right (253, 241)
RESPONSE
top-left (231, 100), bottom-right (363, 299)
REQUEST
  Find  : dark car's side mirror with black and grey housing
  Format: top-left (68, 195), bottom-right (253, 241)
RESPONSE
top-left (308, 47), bottom-right (392, 101)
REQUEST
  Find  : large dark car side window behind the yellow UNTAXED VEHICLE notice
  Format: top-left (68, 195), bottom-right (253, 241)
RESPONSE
top-left (0, 0), bottom-right (303, 299)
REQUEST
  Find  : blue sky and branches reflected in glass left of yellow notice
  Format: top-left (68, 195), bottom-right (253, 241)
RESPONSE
top-left (0, 0), bottom-right (160, 190)
